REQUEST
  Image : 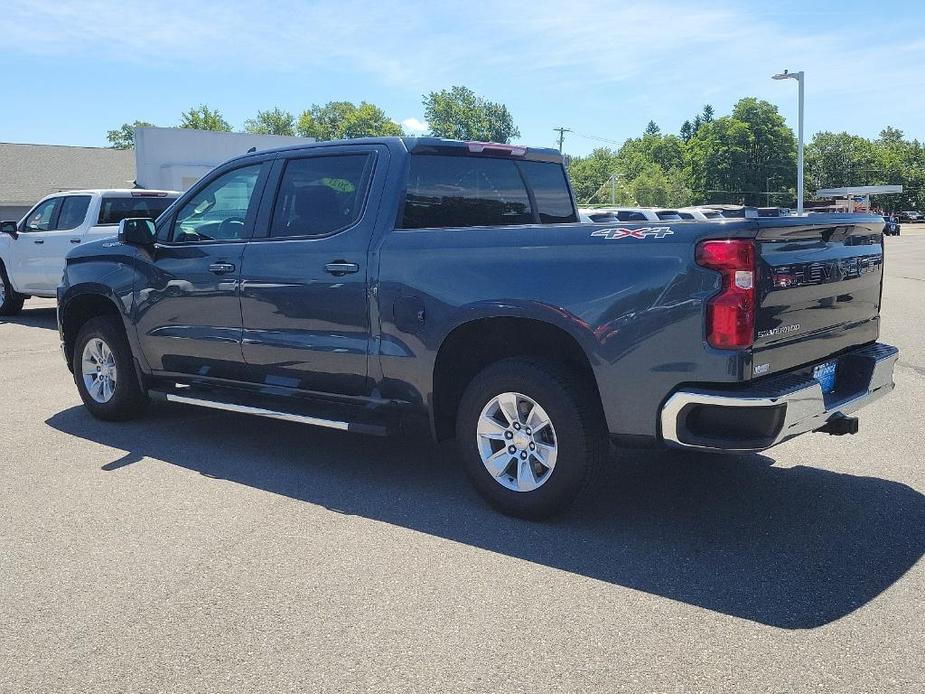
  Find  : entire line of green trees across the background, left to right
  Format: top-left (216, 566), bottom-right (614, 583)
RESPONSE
top-left (107, 86), bottom-right (925, 211)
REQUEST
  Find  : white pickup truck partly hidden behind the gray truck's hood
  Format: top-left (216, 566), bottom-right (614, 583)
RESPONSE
top-left (0, 190), bottom-right (180, 316)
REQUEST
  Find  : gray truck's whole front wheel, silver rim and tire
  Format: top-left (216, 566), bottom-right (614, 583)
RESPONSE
top-left (73, 316), bottom-right (148, 420)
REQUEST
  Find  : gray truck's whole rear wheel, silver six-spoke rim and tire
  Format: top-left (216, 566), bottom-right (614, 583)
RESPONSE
top-left (456, 358), bottom-right (608, 519)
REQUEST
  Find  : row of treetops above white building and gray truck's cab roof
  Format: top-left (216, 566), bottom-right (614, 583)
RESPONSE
top-left (106, 86), bottom-right (520, 149)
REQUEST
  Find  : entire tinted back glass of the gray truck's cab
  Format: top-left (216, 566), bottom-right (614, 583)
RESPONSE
top-left (401, 154), bottom-right (577, 229)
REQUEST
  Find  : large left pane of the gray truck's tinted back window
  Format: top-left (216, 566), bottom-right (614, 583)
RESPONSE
top-left (401, 154), bottom-right (534, 229)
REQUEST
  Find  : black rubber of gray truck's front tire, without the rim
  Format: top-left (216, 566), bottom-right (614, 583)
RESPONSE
top-left (71, 316), bottom-right (148, 421)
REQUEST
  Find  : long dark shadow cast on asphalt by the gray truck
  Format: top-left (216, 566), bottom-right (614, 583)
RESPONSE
top-left (47, 406), bottom-right (925, 629)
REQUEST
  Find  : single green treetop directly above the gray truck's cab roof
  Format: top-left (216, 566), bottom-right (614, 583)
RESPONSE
top-left (424, 86), bottom-right (520, 142)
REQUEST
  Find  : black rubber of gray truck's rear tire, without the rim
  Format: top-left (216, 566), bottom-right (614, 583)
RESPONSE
top-left (456, 357), bottom-right (608, 520)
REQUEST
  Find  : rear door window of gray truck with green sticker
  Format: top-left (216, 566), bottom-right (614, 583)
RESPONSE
top-left (270, 154), bottom-right (372, 237)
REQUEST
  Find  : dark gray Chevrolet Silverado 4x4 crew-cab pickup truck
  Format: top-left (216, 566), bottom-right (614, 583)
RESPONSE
top-left (58, 138), bottom-right (897, 518)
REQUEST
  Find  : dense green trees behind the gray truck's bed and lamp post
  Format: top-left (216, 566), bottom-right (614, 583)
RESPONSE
top-left (568, 97), bottom-right (925, 211)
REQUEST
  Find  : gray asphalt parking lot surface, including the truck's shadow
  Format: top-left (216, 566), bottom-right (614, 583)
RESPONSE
top-left (0, 230), bottom-right (925, 692)
